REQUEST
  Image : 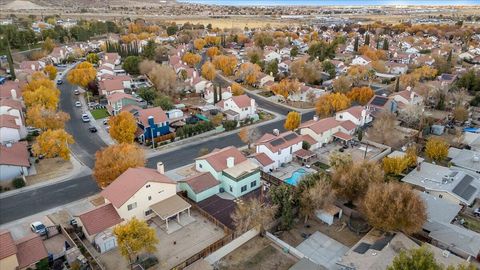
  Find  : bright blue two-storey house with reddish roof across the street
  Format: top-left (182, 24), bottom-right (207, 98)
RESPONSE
top-left (137, 107), bottom-right (170, 142)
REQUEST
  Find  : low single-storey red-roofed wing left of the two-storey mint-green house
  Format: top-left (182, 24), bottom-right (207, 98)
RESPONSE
top-left (179, 172), bottom-right (221, 202)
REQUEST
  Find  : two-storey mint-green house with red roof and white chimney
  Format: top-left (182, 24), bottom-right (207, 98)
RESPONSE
top-left (195, 146), bottom-right (262, 197)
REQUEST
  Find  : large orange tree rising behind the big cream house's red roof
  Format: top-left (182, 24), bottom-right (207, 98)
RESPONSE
top-left (93, 143), bottom-right (145, 188)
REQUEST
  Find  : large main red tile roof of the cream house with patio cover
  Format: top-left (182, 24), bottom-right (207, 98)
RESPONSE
top-left (102, 167), bottom-right (176, 209)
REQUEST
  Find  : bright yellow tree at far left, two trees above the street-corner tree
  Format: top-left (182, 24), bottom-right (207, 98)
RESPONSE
top-left (23, 86), bottom-right (60, 111)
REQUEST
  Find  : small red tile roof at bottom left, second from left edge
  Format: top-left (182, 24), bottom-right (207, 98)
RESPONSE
top-left (17, 234), bottom-right (48, 269)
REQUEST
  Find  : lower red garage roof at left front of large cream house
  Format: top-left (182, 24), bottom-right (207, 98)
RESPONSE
top-left (78, 203), bottom-right (122, 235)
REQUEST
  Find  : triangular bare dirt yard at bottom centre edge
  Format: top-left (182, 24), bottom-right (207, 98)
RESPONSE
top-left (218, 236), bottom-right (297, 270)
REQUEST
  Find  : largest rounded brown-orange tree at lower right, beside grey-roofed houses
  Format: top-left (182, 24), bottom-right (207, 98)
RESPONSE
top-left (361, 182), bottom-right (427, 234)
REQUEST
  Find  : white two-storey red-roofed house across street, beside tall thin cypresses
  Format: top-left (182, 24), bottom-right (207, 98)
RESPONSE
top-left (216, 94), bottom-right (257, 121)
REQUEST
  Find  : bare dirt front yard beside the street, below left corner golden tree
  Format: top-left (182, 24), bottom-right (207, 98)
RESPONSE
top-left (26, 157), bottom-right (73, 185)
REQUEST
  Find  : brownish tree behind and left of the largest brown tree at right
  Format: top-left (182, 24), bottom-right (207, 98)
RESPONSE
top-left (332, 161), bottom-right (384, 201)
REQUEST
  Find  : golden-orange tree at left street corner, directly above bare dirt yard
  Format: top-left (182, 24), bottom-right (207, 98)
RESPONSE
top-left (32, 129), bottom-right (75, 160)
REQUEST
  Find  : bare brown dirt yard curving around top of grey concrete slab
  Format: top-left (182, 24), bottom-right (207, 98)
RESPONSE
top-left (280, 218), bottom-right (363, 247)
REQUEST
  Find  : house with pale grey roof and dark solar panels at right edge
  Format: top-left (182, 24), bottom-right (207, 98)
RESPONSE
top-left (402, 162), bottom-right (480, 205)
